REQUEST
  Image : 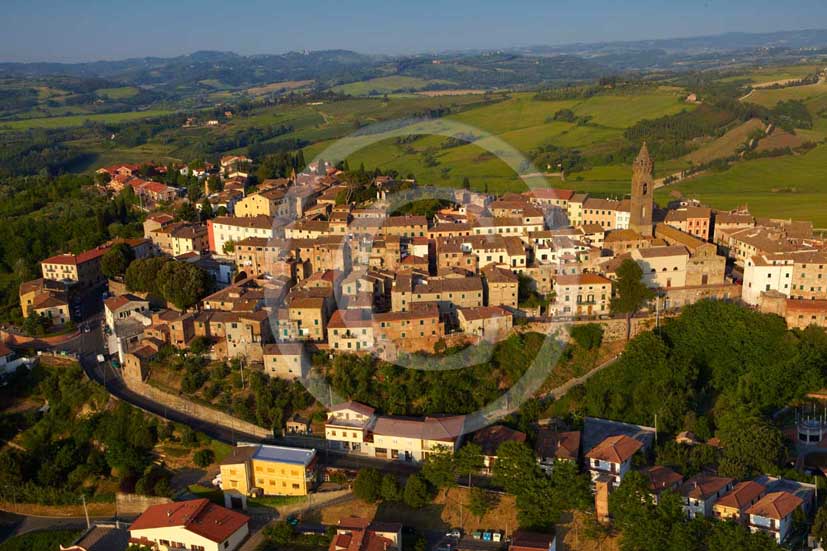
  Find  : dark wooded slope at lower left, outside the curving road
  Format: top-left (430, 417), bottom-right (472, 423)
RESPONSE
top-left (0, 364), bottom-right (173, 504)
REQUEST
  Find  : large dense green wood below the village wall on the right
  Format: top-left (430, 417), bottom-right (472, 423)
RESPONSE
top-left (568, 301), bottom-right (827, 478)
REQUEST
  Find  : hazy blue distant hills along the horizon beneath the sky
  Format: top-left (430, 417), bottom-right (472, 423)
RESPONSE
top-left (0, 30), bottom-right (827, 96)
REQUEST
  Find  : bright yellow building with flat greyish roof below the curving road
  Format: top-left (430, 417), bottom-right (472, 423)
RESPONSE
top-left (221, 445), bottom-right (317, 496)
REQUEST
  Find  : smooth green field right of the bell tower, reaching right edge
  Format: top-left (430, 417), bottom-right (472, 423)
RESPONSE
top-left (657, 145), bottom-right (827, 228)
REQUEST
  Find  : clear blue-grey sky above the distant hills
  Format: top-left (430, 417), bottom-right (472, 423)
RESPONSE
top-left (0, 0), bottom-right (827, 62)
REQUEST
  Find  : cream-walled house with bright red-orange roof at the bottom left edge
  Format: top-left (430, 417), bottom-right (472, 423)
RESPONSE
top-left (129, 499), bottom-right (250, 551)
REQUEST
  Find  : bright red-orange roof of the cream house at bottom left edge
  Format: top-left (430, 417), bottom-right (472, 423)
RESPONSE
top-left (129, 498), bottom-right (250, 543)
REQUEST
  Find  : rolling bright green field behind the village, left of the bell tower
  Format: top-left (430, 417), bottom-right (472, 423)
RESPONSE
top-left (338, 89), bottom-right (694, 194)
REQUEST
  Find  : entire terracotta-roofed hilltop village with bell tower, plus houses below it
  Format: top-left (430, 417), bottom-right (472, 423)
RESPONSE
top-left (9, 144), bottom-right (827, 551)
